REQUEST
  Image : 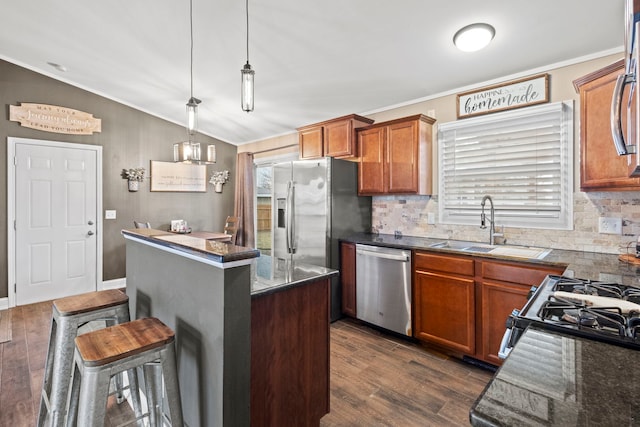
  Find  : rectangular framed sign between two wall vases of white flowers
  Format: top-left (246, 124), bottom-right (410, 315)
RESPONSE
top-left (151, 160), bottom-right (207, 192)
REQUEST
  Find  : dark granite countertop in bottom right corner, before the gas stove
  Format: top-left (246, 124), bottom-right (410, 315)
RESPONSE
top-left (469, 326), bottom-right (640, 426)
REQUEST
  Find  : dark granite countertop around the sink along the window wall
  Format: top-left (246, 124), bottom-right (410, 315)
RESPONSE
top-left (340, 233), bottom-right (640, 287)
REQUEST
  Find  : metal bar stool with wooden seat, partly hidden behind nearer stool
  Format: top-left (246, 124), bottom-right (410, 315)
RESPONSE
top-left (38, 289), bottom-right (142, 427)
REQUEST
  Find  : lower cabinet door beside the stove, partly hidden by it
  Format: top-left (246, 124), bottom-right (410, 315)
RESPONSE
top-left (479, 282), bottom-right (530, 365)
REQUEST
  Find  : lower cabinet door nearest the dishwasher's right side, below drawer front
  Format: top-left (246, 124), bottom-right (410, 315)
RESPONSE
top-left (414, 271), bottom-right (475, 354)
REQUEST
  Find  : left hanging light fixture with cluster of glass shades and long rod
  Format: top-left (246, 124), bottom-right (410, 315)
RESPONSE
top-left (173, 0), bottom-right (216, 164)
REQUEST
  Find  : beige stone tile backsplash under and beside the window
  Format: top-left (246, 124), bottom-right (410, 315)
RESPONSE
top-left (372, 192), bottom-right (640, 254)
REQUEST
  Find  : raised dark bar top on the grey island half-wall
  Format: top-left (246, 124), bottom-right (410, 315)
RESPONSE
top-left (122, 228), bottom-right (260, 263)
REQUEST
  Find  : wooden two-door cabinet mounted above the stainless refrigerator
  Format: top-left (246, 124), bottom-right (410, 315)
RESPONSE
top-left (298, 114), bottom-right (373, 159)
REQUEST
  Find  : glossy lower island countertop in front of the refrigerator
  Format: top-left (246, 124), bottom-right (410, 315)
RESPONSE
top-left (251, 255), bottom-right (338, 297)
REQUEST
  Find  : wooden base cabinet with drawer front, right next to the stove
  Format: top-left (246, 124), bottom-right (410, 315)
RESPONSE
top-left (475, 260), bottom-right (564, 365)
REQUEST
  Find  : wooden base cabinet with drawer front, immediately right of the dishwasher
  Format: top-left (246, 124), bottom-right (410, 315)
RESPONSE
top-left (413, 251), bottom-right (476, 354)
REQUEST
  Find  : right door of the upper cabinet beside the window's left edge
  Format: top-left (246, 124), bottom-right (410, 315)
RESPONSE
top-left (387, 120), bottom-right (419, 194)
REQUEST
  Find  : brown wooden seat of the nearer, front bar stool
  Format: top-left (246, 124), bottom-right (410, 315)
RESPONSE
top-left (76, 317), bottom-right (175, 366)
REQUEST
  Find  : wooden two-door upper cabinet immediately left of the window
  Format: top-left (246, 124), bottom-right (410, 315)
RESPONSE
top-left (356, 114), bottom-right (435, 195)
